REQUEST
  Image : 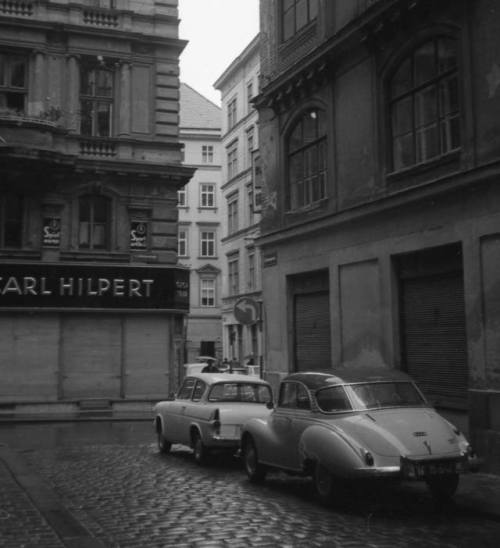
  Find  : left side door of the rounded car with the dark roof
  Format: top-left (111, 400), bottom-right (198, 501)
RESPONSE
top-left (262, 381), bottom-right (311, 470)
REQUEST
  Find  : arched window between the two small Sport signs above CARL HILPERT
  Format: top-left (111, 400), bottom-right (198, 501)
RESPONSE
top-left (78, 195), bottom-right (110, 249)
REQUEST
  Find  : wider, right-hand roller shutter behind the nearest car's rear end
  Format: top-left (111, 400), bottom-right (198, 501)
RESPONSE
top-left (401, 272), bottom-right (468, 409)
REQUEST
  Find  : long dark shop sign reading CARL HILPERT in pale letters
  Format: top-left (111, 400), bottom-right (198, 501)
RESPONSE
top-left (0, 263), bottom-right (189, 310)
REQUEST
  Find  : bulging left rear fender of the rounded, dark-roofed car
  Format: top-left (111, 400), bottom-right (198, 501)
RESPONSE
top-left (299, 425), bottom-right (365, 477)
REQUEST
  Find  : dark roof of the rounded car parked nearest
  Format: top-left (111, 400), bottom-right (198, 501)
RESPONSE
top-left (283, 367), bottom-right (412, 390)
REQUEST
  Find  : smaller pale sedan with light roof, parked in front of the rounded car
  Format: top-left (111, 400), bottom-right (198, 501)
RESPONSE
top-left (153, 373), bottom-right (273, 464)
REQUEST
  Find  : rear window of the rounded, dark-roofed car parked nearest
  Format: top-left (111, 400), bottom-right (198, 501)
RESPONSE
top-left (349, 381), bottom-right (426, 409)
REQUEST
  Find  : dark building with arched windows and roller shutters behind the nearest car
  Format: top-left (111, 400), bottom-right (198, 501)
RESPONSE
top-left (257, 0), bottom-right (500, 472)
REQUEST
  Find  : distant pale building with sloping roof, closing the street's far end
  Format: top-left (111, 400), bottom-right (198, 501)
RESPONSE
top-left (177, 83), bottom-right (222, 363)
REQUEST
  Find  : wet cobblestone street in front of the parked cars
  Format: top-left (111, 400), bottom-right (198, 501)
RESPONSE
top-left (0, 423), bottom-right (500, 548)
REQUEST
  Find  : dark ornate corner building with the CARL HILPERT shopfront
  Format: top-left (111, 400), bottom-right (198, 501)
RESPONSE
top-left (0, 0), bottom-right (193, 413)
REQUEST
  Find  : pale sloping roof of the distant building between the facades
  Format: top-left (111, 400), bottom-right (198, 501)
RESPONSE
top-left (179, 82), bottom-right (222, 131)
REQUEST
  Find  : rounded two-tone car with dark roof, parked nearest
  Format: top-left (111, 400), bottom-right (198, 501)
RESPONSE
top-left (241, 369), bottom-right (477, 502)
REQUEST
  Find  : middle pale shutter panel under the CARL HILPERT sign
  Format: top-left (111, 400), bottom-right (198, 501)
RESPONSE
top-left (61, 314), bottom-right (122, 399)
